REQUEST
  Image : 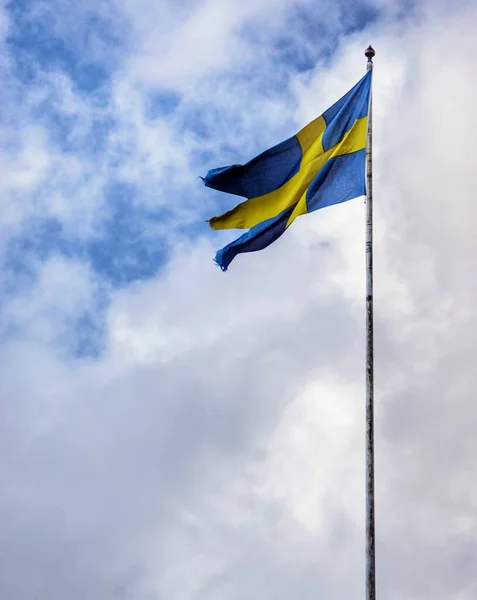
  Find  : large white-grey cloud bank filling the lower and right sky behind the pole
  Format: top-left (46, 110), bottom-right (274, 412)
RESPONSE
top-left (0, 3), bottom-right (477, 600)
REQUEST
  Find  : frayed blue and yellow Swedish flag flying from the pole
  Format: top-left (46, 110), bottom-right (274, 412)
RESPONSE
top-left (203, 71), bottom-right (372, 271)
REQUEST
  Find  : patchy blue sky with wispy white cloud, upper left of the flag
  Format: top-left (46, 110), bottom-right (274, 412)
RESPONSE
top-left (3, 0), bottom-right (390, 356)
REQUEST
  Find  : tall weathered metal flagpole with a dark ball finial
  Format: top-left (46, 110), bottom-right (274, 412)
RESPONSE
top-left (364, 46), bottom-right (376, 600)
